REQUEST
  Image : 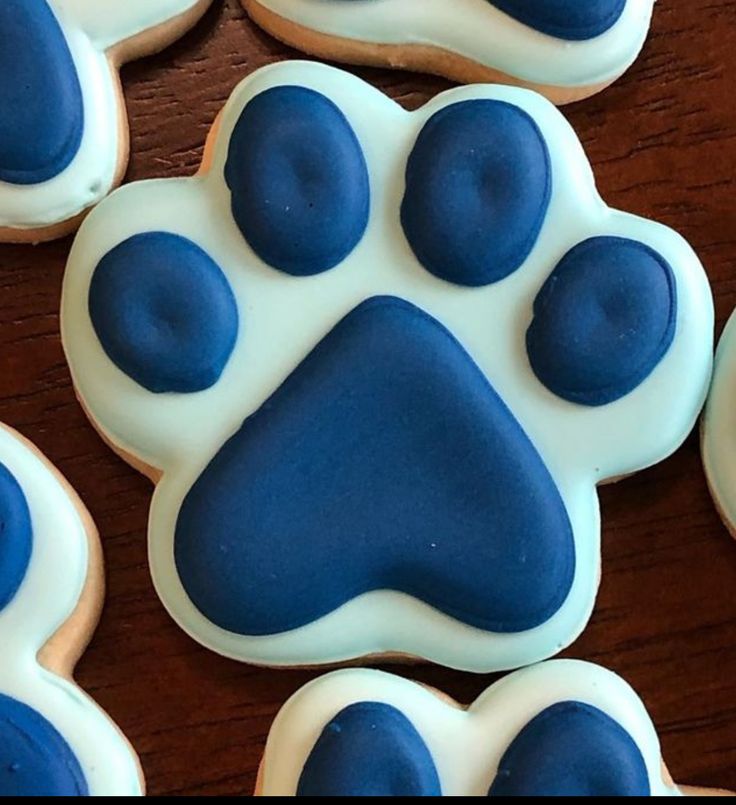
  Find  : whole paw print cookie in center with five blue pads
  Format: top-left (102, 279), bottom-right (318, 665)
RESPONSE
top-left (62, 62), bottom-right (713, 672)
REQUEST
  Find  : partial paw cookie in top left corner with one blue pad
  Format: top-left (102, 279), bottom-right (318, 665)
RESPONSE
top-left (0, 0), bottom-right (212, 242)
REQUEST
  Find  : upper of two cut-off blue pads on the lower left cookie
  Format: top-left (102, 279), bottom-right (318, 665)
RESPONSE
top-left (0, 464), bottom-right (33, 611)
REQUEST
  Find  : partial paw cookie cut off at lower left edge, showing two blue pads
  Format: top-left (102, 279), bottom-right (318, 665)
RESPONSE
top-left (0, 427), bottom-right (143, 797)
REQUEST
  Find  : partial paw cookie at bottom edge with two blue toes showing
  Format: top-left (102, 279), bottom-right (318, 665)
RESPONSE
top-left (256, 660), bottom-right (725, 797)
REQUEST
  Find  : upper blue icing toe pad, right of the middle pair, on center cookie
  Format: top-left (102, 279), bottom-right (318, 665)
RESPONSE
top-left (401, 100), bottom-right (552, 286)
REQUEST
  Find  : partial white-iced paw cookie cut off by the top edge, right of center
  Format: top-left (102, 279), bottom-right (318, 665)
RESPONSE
top-left (242, 0), bottom-right (654, 104)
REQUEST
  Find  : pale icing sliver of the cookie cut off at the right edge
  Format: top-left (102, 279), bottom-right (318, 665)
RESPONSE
top-left (702, 314), bottom-right (736, 531)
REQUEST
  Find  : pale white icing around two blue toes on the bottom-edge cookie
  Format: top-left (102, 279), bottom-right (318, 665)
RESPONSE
top-left (262, 660), bottom-right (680, 797)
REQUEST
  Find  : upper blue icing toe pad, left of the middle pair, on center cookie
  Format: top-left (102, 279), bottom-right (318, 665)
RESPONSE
top-left (225, 86), bottom-right (370, 276)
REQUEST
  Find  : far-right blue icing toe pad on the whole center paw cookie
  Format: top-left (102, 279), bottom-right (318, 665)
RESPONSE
top-left (526, 237), bottom-right (677, 405)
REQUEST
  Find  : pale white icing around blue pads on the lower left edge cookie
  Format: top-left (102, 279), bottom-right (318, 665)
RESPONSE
top-left (0, 427), bottom-right (142, 796)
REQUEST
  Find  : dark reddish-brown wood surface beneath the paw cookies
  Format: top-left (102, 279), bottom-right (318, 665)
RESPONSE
top-left (0, 0), bottom-right (736, 795)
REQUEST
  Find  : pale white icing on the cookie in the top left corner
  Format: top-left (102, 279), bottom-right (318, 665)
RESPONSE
top-left (0, 0), bottom-right (211, 230)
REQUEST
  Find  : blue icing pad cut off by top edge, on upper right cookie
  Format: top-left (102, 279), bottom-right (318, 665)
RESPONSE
top-left (490, 0), bottom-right (626, 40)
